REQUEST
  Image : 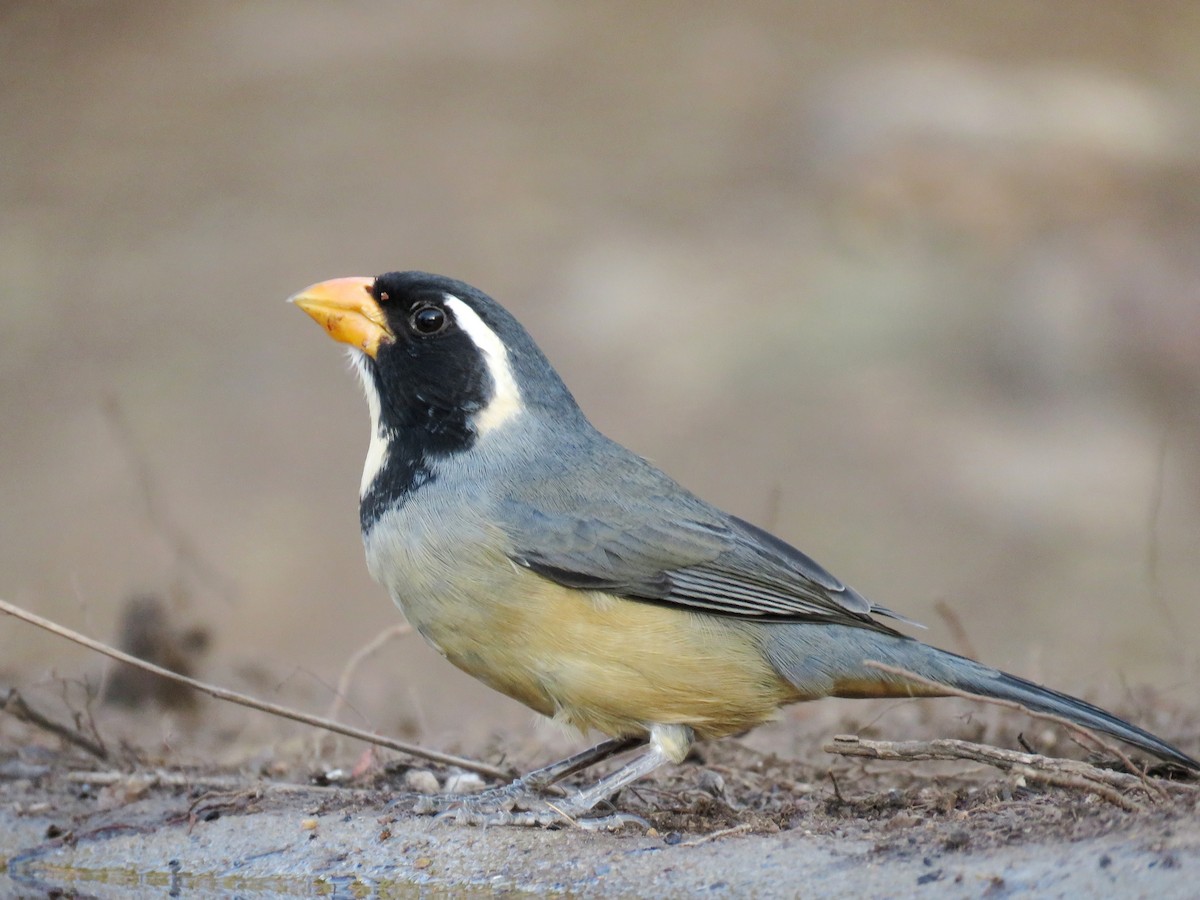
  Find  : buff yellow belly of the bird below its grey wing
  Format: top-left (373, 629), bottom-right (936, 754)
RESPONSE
top-left (397, 562), bottom-right (799, 738)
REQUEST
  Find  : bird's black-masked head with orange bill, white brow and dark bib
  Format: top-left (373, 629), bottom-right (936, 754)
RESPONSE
top-left (293, 271), bottom-right (582, 528)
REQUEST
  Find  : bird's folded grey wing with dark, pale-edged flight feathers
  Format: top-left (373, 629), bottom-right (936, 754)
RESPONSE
top-left (499, 448), bottom-right (900, 631)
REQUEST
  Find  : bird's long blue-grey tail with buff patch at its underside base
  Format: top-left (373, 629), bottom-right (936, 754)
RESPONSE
top-left (762, 624), bottom-right (1200, 772)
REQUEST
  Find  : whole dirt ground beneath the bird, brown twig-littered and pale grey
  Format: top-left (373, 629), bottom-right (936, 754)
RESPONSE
top-left (0, 681), bottom-right (1200, 898)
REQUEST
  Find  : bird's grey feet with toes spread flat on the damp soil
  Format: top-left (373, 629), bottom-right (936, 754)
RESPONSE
top-left (413, 780), bottom-right (649, 832)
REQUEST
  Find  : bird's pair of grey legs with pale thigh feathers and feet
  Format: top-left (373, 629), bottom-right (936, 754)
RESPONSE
top-left (414, 726), bottom-right (692, 829)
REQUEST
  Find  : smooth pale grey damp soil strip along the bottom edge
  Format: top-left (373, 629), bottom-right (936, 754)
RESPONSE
top-left (0, 786), bottom-right (1200, 898)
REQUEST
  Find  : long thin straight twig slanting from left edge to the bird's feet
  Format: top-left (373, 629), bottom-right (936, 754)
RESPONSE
top-left (0, 600), bottom-right (512, 780)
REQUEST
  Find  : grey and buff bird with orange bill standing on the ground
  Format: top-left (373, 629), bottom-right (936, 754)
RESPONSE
top-left (290, 271), bottom-right (1200, 827)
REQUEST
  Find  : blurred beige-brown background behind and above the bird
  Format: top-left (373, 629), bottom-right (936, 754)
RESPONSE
top-left (0, 0), bottom-right (1200, 758)
